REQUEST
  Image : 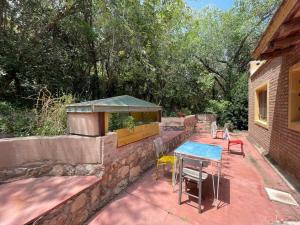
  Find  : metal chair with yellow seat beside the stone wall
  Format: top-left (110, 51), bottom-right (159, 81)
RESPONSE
top-left (154, 137), bottom-right (176, 185)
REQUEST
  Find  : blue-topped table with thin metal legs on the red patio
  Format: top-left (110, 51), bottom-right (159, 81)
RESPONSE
top-left (174, 141), bottom-right (223, 200)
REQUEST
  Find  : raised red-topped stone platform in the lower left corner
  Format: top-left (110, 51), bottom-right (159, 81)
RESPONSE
top-left (0, 176), bottom-right (100, 225)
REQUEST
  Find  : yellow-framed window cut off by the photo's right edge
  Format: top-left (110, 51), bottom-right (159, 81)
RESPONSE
top-left (289, 63), bottom-right (300, 132)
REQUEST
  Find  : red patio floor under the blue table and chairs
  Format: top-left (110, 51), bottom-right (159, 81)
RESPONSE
top-left (88, 134), bottom-right (300, 225)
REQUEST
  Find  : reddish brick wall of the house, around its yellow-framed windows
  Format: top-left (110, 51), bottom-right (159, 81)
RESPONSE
top-left (249, 46), bottom-right (300, 180)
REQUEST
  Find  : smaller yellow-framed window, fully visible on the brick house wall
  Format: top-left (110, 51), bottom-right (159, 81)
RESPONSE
top-left (255, 83), bottom-right (269, 128)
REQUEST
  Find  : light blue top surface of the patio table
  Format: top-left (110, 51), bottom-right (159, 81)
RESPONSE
top-left (175, 141), bottom-right (222, 161)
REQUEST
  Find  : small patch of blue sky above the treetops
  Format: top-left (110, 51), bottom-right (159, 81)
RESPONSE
top-left (186, 0), bottom-right (234, 10)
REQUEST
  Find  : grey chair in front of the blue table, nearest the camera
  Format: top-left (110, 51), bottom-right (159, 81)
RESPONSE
top-left (178, 157), bottom-right (214, 213)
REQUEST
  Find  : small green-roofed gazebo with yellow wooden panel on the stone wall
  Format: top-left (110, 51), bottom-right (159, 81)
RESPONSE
top-left (67, 95), bottom-right (162, 146)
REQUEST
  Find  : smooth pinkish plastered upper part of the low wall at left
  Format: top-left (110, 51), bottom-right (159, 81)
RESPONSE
top-left (0, 135), bottom-right (102, 169)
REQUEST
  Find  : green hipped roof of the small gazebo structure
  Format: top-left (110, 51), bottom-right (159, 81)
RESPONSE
top-left (67, 95), bottom-right (162, 112)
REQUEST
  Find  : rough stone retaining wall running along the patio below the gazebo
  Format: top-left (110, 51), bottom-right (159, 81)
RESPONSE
top-left (32, 132), bottom-right (191, 225)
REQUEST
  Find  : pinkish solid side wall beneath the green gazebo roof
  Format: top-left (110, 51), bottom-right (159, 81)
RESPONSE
top-left (68, 113), bottom-right (100, 136)
